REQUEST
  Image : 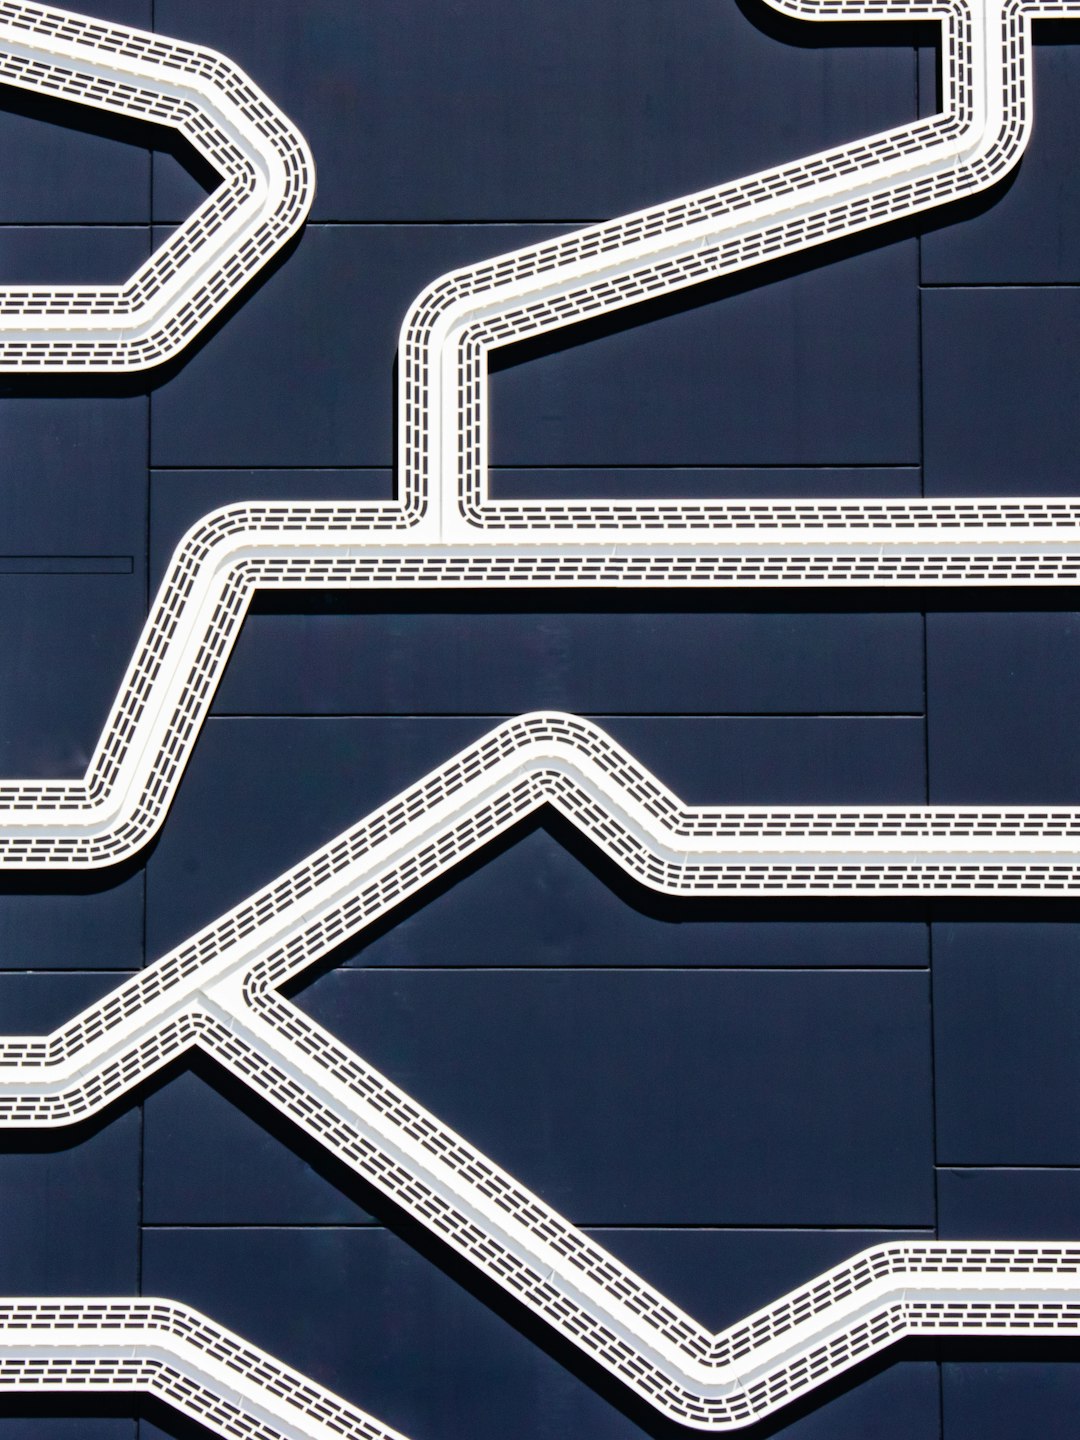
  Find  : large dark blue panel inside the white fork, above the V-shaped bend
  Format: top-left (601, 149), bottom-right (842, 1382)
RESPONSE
top-left (302, 968), bottom-right (933, 1225)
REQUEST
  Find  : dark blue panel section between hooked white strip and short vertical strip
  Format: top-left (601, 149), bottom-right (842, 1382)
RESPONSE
top-left (151, 225), bottom-right (576, 468)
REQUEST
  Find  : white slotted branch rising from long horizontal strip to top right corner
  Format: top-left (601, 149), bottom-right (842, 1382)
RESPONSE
top-left (399, 0), bottom-right (1080, 539)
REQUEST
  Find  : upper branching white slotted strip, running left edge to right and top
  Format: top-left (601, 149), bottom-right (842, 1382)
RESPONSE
top-left (0, 0), bottom-right (1080, 867)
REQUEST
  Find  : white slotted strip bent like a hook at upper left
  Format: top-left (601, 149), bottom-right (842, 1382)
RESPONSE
top-left (0, 0), bottom-right (315, 373)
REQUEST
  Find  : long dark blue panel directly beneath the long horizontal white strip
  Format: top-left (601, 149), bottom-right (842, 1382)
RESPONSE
top-left (215, 607), bottom-right (923, 720)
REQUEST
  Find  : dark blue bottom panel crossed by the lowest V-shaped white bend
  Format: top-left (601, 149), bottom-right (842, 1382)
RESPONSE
top-left (144, 1227), bottom-right (937, 1440)
